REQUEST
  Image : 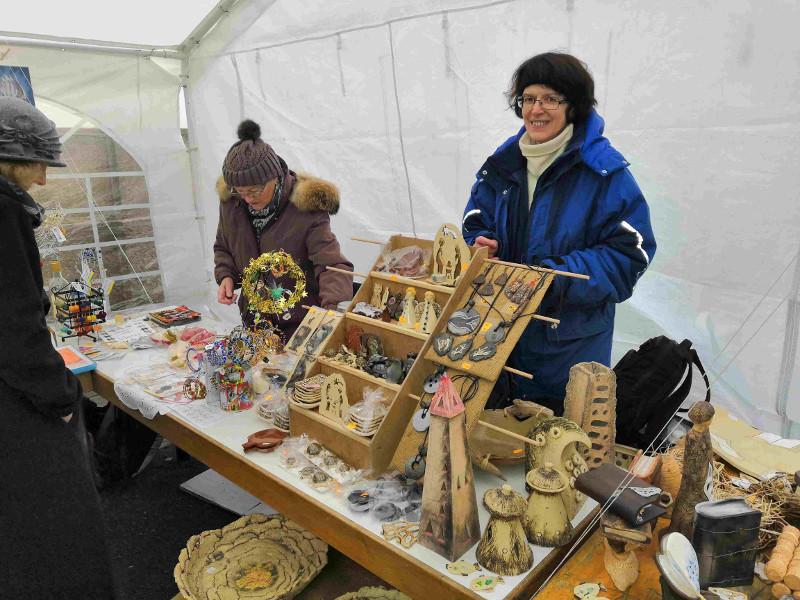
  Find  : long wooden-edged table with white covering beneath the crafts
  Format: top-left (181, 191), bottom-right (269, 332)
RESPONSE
top-left (84, 324), bottom-right (596, 599)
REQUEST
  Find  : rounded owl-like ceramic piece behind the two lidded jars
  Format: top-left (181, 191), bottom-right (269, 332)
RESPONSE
top-left (525, 417), bottom-right (592, 519)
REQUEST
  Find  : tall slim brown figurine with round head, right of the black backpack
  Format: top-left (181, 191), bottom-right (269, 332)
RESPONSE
top-left (668, 401), bottom-right (714, 539)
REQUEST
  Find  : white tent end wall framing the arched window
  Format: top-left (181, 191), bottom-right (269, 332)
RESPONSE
top-left (0, 47), bottom-right (210, 302)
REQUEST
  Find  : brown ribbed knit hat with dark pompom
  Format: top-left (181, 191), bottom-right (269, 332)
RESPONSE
top-left (222, 119), bottom-right (284, 187)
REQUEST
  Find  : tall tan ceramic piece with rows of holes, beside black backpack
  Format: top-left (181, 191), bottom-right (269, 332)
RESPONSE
top-left (564, 362), bottom-right (617, 469)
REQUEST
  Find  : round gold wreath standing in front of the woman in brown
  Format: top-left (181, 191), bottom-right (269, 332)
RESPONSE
top-left (242, 250), bottom-right (307, 315)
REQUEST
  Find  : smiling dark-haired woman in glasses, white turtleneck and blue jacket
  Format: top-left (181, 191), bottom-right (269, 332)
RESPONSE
top-left (462, 52), bottom-right (656, 414)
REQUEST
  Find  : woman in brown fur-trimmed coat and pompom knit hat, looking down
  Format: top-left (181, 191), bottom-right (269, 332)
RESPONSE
top-left (214, 120), bottom-right (353, 339)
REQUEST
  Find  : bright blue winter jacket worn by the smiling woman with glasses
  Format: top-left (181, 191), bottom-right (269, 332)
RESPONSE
top-left (462, 111), bottom-right (656, 411)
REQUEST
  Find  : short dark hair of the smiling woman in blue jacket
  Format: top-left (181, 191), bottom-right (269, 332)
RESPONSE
top-left (506, 52), bottom-right (597, 123)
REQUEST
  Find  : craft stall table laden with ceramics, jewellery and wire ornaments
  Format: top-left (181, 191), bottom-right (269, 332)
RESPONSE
top-left (65, 226), bottom-right (800, 598)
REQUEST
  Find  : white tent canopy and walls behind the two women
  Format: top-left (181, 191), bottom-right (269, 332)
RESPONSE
top-left (0, 0), bottom-right (800, 438)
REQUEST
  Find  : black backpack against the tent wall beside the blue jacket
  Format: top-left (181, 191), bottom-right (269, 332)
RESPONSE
top-left (614, 336), bottom-right (711, 449)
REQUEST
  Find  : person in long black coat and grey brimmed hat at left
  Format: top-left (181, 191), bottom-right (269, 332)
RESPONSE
top-left (0, 98), bottom-right (117, 600)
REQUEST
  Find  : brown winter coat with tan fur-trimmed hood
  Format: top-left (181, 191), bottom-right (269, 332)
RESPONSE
top-left (214, 169), bottom-right (353, 335)
